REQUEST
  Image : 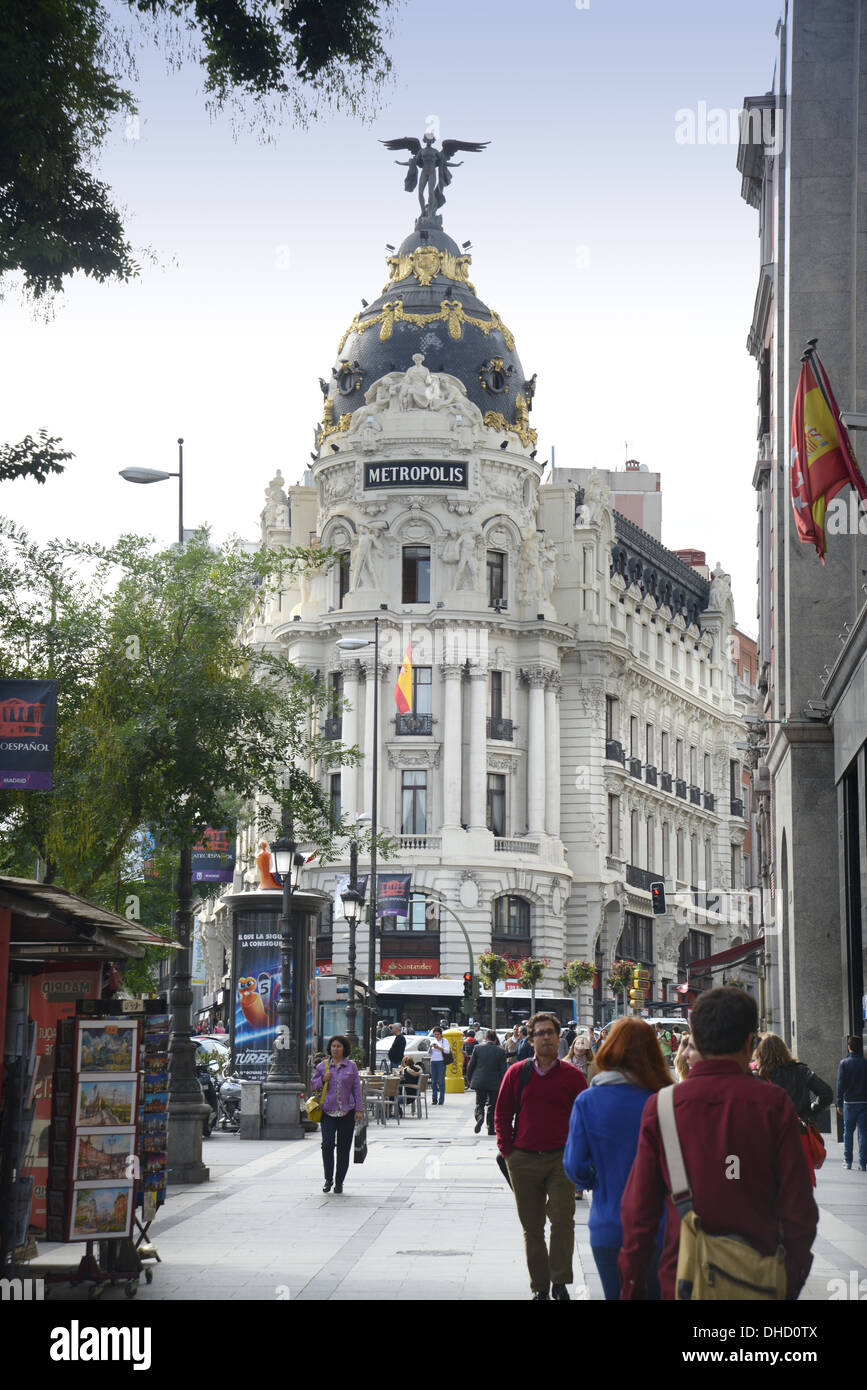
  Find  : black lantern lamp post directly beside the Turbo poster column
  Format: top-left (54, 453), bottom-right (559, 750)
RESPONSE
top-left (263, 835), bottom-right (307, 1138)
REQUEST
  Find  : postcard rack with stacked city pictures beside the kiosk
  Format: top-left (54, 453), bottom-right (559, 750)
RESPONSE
top-left (44, 999), bottom-right (168, 1298)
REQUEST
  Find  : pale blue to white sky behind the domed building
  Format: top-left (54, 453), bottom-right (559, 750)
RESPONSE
top-left (0, 0), bottom-right (782, 632)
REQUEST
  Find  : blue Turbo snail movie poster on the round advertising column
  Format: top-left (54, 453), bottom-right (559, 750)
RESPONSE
top-left (232, 919), bottom-right (281, 1081)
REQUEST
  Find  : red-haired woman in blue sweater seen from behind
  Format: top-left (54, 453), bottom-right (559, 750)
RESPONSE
top-left (563, 1017), bottom-right (671, 1300)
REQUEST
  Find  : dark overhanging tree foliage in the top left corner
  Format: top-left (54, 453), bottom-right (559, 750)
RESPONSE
top-left (0, 0), bottom-right (396, 297)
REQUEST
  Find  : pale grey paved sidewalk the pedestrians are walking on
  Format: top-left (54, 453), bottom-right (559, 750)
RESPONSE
top-left (32, 1094), bottom-right (867, 1304)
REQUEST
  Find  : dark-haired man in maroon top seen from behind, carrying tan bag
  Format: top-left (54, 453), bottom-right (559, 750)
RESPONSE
top-left (618, 988), bottom-right (818, 1298)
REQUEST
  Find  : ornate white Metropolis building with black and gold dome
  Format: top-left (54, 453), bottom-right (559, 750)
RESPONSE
top-left (195, 165), bottom-right (750, 1022)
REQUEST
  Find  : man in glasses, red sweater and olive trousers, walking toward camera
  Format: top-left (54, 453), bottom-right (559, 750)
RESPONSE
top-left (493, 1013), bottom-right (586, 1302)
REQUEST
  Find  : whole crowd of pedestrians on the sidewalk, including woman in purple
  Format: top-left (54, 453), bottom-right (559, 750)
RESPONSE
top-left (313, 987), bottom-right (867, 1302)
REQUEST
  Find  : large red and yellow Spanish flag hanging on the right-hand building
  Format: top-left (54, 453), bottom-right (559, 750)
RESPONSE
top-left (791, 338), bottom-right (867, 564)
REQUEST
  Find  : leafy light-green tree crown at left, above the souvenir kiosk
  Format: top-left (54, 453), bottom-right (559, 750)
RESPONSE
top-left (0, 524), bottom-right (358, 906)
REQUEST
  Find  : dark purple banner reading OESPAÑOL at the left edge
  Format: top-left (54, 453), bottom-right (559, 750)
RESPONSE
top-left (0, 680), bottom-right (57, 791)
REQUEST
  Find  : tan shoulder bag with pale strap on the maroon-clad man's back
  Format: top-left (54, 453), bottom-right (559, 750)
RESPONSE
top-left (656, 1086), bottom-right (786, 1302)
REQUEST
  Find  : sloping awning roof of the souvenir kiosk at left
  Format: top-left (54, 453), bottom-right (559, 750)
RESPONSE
top-left (0, 877), bottom-right (179, 960)
